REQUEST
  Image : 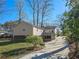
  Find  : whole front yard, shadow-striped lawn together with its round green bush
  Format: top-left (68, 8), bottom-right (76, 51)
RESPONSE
top-left (0, 36), bottom-right (44, 59)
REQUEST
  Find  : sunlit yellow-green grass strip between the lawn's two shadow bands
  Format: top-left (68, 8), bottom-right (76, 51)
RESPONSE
top-left (0, 43), bottom-right (31, 53)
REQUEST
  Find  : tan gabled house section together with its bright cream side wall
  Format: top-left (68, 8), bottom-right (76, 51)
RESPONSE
top-left (12, 21), bottom-right (43, 36)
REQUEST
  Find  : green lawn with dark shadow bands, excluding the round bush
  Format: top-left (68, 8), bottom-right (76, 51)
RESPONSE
top-left (0, 42), bottom-right (32, 59)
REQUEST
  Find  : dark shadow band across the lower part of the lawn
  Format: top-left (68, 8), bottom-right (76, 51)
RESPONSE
top-left (1, 48), bottom-right (32, 57)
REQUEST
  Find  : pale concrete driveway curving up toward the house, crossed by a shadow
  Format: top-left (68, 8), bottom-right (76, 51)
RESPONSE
top-left (19, 37), bottom-right (69, 59)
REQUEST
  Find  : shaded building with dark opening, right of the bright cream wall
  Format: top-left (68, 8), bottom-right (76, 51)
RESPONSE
top-left (42, 26), bottom-right (55, 41)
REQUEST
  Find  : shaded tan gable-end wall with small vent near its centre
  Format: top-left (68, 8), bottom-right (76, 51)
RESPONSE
top-left (13, 22), bottom-right (33, 36)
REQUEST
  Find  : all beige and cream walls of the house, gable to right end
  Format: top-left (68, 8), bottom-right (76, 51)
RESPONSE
top-left (13, 22), bottom-right (55, 41)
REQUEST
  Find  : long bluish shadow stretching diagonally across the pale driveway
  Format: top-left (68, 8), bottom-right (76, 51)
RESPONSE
top-left (32, 45), bottom-right (68, 59)
